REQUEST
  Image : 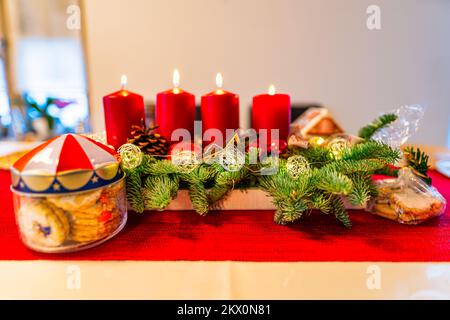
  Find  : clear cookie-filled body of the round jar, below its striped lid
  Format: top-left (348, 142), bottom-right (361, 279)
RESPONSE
top-left (11, 177), bottom-right (127, 253)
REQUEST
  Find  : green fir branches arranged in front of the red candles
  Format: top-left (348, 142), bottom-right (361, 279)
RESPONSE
top-left (124, 110), bottom-right (428, 228)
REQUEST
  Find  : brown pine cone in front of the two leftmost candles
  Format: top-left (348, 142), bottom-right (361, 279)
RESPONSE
top-left (127, 121), bottom-right (169, 157)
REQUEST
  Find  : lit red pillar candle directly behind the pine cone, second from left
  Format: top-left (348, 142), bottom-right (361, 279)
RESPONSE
top-left (155, 70), bottom-right (195, 142)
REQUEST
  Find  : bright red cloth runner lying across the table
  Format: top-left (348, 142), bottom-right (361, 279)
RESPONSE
top-left (0, 171), bottom-right (450, 261)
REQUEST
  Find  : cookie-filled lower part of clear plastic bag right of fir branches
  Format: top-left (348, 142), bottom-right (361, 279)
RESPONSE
top-left (368, 168), bottom-right (446, 225)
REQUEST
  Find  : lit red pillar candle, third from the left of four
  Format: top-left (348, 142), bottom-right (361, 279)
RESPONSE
top-left (201, 73), bottom-right (239, 145)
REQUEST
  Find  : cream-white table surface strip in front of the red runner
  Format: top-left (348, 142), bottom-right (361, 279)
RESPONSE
top-left (0, 261), bottom-right (450, 299)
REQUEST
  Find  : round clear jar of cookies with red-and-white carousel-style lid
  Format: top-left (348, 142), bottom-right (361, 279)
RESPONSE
top-left (11, 134), bottom-right (127, 253)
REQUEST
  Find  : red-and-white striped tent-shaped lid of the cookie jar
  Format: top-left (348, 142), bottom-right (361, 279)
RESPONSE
top-left (11, 134), bottom-right (123, 194)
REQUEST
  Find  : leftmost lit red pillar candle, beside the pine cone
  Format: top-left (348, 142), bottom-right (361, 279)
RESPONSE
top-left (103, 75), bottom-right (145, 149)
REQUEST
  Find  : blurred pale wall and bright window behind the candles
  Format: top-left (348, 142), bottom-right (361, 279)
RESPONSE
top-left (0, 0), bottom-right (450, 148)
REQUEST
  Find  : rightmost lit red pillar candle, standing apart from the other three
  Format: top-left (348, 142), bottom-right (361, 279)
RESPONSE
top-left (252, 85), bottom-right (291, 142)
